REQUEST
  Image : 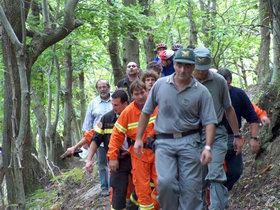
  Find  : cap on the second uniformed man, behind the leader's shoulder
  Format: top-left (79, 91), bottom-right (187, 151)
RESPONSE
top-left (194, 47), bottom-right (212, 71)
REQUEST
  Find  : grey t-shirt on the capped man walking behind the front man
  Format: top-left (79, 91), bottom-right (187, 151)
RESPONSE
top-left (199, 70), bottom-right (231, 122)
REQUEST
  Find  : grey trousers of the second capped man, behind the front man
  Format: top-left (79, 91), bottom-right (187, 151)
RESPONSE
top-left (203, 126), bottom-right (228, 210)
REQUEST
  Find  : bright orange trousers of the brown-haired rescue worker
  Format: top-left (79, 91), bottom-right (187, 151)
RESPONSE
top-left (131, 149), bottom-right (159, 210)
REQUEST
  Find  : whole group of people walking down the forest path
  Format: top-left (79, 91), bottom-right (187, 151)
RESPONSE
top-left (65, 43), bottom-right (269, 210)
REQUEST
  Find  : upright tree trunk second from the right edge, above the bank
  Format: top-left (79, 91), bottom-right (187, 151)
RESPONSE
top-left (256, 0), bottom-right (271, 84)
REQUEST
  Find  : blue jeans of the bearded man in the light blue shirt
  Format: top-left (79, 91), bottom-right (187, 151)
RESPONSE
top-left (96, 147), bottom-right (110, 190)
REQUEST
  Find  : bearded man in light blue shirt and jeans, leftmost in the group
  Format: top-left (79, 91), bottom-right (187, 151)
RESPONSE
top-left (82, 79), bottom-right (112, 196)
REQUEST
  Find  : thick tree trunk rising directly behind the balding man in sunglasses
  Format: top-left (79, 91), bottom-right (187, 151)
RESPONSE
top-left (123, 0), bottom-right (140, 68)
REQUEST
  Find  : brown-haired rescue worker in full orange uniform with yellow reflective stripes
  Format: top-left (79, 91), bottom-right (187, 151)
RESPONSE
top-left (107, 80), bottom-right (158, 210)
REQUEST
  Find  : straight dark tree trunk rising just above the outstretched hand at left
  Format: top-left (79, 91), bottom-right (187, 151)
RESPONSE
top-left (63, 44), bottom-right (73, 148)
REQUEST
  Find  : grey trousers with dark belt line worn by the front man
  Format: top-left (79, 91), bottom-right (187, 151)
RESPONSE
top-left (155, 134), bottom-right (203, 210)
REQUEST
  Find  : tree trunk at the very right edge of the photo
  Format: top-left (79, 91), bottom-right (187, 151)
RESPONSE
top-left (271, 0), bottom-right (280, 84)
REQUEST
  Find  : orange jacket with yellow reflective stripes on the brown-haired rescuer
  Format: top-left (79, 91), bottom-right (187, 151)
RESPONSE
top-left (107, 101), bottom-right (158, 162)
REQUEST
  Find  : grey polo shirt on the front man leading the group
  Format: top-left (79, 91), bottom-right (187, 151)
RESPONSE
top-left (142, 74), bottom-right (217, 133)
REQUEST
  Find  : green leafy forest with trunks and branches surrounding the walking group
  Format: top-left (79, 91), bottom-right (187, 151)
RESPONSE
top-left (0, 0), bottom-right (280, 209)
